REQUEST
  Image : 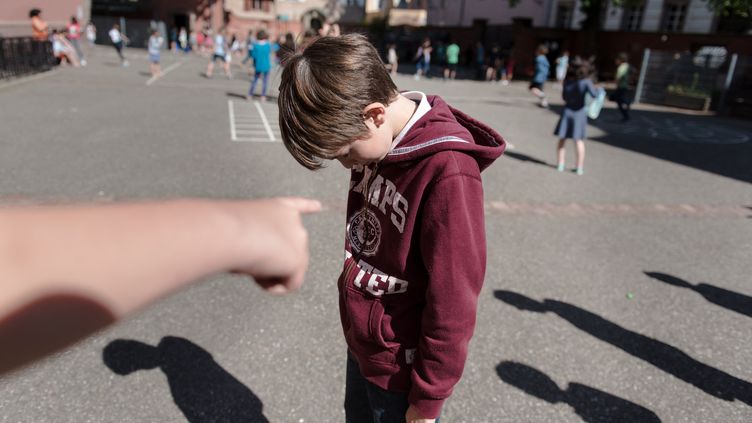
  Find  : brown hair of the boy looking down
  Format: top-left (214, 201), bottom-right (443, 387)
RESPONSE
top-left (278, 34), bottom-right (398, 170)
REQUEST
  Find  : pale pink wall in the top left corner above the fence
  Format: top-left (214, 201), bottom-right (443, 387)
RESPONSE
top-left (0, 0), bottom-right (83, 37)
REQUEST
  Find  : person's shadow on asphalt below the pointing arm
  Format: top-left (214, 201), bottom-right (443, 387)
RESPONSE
top-left (102, 336), bottom-right (269, 423)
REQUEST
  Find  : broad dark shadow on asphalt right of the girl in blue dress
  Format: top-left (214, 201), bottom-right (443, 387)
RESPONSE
top-left (550, 105), bottom-right (752, 182)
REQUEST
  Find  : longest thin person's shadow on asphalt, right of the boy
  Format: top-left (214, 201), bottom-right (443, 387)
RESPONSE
top-left (494, 290), bottom-right (752, 405)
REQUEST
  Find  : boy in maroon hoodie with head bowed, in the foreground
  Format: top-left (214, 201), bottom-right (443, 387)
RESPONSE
top-left (279, 34), bottom-right (505, 423)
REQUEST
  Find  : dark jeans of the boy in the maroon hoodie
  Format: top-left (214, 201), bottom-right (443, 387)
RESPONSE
top-left (345, 352), bottom-right (439, 423)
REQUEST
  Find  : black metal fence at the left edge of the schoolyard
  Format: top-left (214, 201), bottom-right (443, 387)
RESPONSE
top-left (0, 37), bottom-right (56, 80)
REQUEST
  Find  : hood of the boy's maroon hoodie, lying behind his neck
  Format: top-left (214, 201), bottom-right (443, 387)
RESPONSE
top-left (382, 96), bottom-right (506, 171)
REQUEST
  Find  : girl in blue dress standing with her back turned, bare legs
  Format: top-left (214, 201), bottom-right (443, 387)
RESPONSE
top-left (554, 60), bottom-right (598, 175)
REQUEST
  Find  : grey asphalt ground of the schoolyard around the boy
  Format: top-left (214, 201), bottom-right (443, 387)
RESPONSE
top-left (0, 44), bottom-right (752, 423)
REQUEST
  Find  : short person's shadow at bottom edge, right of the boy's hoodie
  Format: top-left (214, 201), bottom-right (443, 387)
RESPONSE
top-left (496, 361), bottom-right (661, 423)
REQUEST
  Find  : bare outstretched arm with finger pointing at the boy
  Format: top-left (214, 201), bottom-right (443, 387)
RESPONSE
top-left (0, 198), bottom-right (321, 375)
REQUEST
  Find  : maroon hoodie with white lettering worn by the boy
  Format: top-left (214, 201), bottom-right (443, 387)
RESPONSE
top-left (338, 96), bottom-right (505, 418)
